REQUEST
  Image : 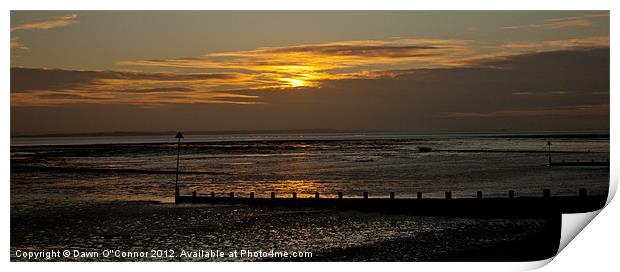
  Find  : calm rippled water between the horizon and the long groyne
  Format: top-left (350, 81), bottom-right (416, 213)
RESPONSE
top-left (11, 134), bottom-right (609, 206)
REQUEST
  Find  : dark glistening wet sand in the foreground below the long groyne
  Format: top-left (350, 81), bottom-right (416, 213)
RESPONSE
top-left (11, 202), bottom-right (559, 261)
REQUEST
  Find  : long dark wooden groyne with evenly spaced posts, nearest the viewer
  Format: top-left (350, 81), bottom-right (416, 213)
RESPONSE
top-left (175, 189), bottom-right (607, 216)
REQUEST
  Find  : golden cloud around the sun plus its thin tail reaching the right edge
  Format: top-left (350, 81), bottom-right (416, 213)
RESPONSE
top-left (118, 34), bottom-right (609, 90)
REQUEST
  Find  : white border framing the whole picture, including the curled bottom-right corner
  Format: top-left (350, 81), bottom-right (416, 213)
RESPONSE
top-left (0, 0), bottom-right (620, 272)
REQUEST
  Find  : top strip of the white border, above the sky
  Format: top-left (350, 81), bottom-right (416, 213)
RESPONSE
top-left (5, 0), bottom-right (613, 10)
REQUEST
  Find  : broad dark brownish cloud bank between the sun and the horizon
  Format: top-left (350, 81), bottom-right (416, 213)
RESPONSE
top-left (11, 47), bottom-right (610, 131)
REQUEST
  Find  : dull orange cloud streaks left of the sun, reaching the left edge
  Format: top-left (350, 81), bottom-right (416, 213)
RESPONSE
top-left (11, 68), bottom-right (260, 106)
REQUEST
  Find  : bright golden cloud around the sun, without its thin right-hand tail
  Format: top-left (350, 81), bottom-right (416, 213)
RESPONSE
top-left (118, 39), bottom-right (475, 89)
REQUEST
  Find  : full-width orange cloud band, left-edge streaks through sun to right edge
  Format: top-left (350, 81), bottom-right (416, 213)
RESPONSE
top-left (11, 37), bottom-right (609, 109)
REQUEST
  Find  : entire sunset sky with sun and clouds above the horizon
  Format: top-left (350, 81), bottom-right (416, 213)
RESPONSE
top-left (10, 11), bottom-right (610, 133)
